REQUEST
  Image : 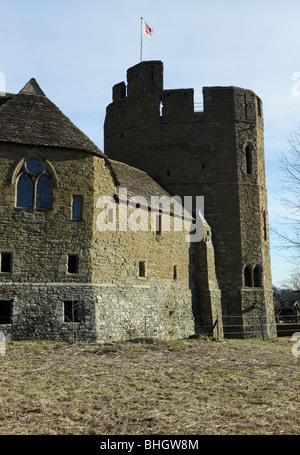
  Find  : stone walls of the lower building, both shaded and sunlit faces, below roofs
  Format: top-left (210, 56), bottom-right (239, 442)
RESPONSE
top-left (0, 145), bottom-right (196, 342)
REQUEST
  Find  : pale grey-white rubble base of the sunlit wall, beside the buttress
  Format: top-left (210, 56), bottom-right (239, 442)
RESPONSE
top-left (95, 283), bottom-right (195, 340)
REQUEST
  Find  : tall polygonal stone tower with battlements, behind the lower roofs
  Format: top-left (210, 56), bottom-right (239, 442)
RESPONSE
top-left (104, 61), bottom-right (275, 336)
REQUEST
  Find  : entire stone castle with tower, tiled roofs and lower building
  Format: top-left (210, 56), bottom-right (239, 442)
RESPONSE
top-left (0, 61), bottom-right (276, 342)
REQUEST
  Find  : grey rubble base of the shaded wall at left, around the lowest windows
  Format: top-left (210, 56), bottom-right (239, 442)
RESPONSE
top-left (0, 282), bottom-right (98, 342)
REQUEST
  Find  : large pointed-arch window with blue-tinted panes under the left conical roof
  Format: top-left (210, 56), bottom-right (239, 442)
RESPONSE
top-left (17, 158), bottom-right (53, 210)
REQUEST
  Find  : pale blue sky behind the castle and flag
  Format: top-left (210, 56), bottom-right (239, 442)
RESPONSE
top-left (0, 0), bottom-right (300, 285)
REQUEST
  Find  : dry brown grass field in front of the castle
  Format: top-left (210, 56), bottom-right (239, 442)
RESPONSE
top-left (0, 338), bottom-right (300, 435)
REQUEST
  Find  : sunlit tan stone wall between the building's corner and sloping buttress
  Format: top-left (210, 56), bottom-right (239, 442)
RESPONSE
top-left (91, 182), bottom-right (203, 339)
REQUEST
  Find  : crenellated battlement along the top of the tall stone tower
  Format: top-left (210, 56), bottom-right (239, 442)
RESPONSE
top-left (108, 61), bottom-right (262, 122)
